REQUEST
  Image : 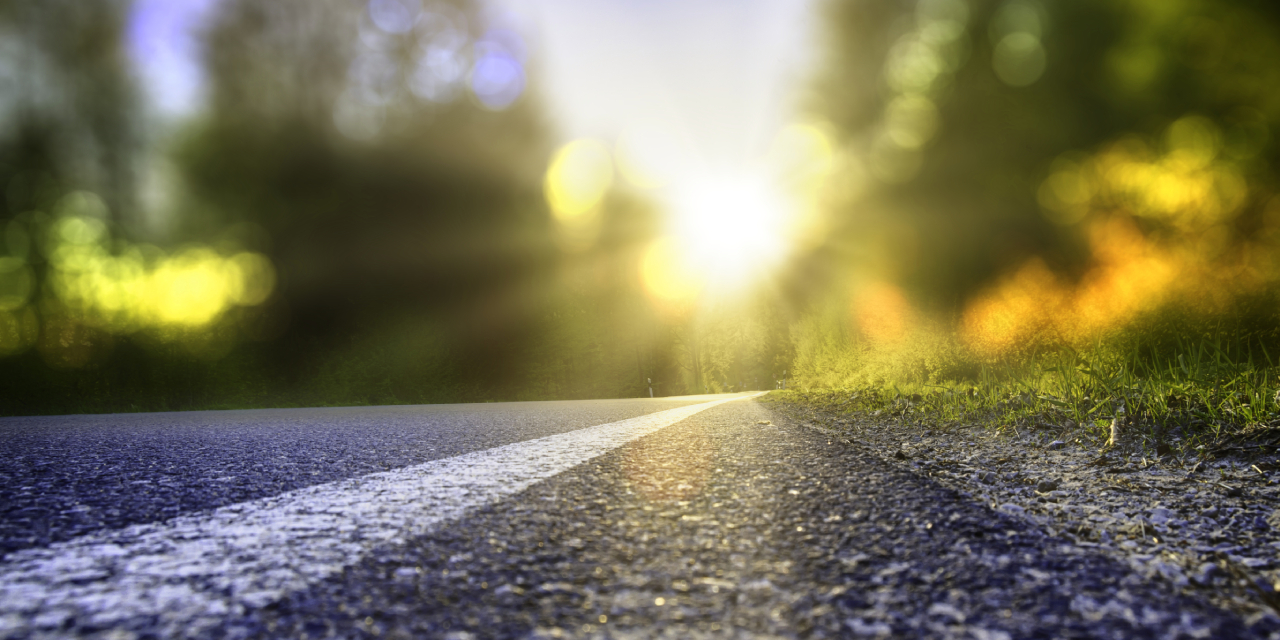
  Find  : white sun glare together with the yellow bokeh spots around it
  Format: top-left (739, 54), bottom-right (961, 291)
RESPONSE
top-left (543, 123), bottom-right (835, 307)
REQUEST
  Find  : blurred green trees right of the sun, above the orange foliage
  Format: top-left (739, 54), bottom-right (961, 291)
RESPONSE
top-left (810, 0), bottom-right (1280, 315)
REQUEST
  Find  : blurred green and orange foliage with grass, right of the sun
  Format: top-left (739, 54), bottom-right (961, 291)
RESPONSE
top-left (792, 0), bottom-right (1280, 443)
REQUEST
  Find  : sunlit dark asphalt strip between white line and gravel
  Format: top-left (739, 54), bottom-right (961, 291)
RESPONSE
top-left (222, 401), bottom-right (1259, 640)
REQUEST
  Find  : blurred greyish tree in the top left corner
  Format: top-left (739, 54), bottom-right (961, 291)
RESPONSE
top-left (0, 0), bottom-right (141, 223)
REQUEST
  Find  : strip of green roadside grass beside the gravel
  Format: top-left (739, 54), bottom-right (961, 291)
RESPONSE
top-left (768, 332), bottom-right (1280, 456)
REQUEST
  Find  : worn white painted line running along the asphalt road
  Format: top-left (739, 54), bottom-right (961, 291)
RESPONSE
top-left (0, 394), bottom-right (759, 637)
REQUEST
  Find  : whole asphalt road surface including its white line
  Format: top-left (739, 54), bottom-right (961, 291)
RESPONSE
top-left (0, 394), bottom-right (1251, 640)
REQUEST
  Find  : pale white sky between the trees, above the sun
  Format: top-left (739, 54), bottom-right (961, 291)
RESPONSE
top-left (524, 0), bottom-right (813, 170)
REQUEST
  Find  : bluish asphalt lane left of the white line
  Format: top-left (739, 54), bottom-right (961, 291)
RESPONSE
top-left (0, 396), bottom-right (714, 556)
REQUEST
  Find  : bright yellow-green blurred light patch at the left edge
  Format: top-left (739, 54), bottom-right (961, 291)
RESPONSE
top-left (0, 186), bottom-right (275, 367)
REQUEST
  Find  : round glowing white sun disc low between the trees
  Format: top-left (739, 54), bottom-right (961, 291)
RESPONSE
top-left (669, 174), bottom-right (787, 289)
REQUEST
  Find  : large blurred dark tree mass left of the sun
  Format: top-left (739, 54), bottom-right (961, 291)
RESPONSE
top-left (180, 0), bottom-right (553, 389)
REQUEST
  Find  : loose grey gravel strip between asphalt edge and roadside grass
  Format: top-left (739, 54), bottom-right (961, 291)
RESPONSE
top-left (768, 394), bottom-right (1280, 632)
